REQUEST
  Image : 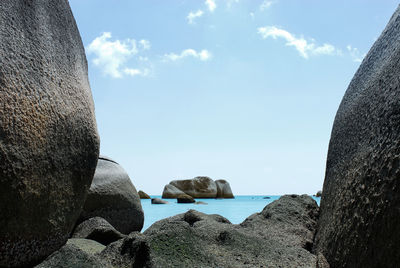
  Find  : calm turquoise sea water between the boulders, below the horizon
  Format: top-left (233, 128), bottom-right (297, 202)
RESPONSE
top-left (141, 195), bottom-right (320, 231)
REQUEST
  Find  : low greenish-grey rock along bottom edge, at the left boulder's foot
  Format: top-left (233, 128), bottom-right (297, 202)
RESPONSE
top-left (35, 238), bottom-right (108, 268)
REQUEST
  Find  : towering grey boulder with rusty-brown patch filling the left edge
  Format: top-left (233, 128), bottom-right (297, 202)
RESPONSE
top-left (0, 0), bottom-right (99, 267)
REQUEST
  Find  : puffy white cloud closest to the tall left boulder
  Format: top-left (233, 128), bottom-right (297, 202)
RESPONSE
top-left (86, 32), bottom-right (150, 78)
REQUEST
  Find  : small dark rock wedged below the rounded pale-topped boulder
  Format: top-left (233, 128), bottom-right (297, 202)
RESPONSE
top-left (72, 217), bottom-right (124, 246)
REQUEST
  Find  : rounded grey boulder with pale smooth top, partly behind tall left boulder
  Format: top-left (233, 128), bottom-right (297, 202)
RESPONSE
top-left (81, 156), bottom-right (144, 234)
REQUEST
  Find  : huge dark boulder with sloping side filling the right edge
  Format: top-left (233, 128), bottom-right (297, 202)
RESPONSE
top-left (316, 6), bottom-right (400, 268)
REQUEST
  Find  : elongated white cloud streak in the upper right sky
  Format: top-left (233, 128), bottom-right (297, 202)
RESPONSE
top-left (258, 26), bottom-right (341, 59)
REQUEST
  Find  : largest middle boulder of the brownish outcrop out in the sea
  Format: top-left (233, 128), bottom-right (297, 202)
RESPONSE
top-left (169, 177), bottom-right (217, 198)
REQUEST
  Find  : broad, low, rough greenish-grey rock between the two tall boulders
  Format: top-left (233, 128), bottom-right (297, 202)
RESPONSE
top-left (98, 195), bottom-right (326, 267)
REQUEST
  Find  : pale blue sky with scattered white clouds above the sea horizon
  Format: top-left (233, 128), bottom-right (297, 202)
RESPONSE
top-left (69, 0), bottom-right (398, 195)
